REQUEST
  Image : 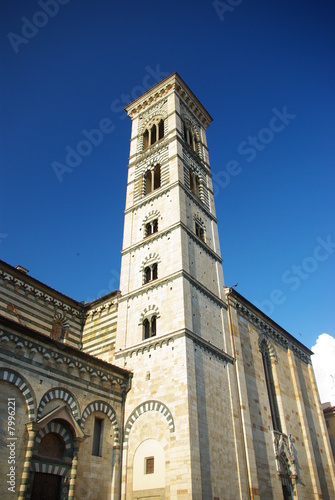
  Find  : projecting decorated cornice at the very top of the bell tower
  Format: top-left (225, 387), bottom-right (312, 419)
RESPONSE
top-left (124, 71), bottom-right (213, 128)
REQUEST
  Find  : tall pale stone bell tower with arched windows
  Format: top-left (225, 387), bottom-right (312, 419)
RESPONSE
top-left (115, 73), bottom-right (245, 499)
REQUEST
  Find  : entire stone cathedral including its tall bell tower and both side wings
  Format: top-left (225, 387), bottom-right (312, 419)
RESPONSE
top-left (0, 73), bottom-right (335, 500)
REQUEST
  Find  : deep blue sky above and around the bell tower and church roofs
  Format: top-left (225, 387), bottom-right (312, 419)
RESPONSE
top-left (0, 0), bottom-right (335, 360)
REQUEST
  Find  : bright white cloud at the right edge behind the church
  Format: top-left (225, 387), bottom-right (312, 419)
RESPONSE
top-left (312, 333), bottom-right (335, 406)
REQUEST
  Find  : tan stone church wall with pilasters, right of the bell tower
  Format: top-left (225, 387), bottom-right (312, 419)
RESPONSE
top-left (229, 291), bottom-right (334, 500)
